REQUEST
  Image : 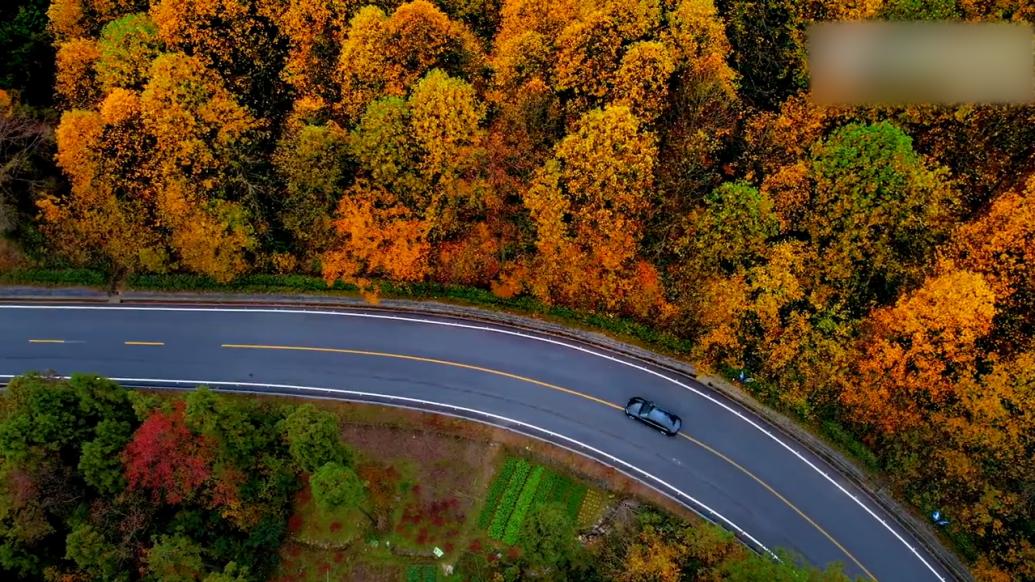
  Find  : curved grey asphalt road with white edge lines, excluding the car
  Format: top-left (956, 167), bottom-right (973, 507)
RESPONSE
top-left (0, 304), bottom-right (949, 581)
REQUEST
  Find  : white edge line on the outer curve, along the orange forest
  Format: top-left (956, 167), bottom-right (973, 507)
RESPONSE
top-left (0, 305), bottom-right (945, 582)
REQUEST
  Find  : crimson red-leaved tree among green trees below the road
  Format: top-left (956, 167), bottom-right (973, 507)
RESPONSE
top-left (122, 401), bottom-right (212, 503)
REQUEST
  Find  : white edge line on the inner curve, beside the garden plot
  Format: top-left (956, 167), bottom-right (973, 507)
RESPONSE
top-left (0, 374), bottom-right (779, 560)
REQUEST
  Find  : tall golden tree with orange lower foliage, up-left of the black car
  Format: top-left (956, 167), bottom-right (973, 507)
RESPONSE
top-left (517, 106), bottom-right (669, 318)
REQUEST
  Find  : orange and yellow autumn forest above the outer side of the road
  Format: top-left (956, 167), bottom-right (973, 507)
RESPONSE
top-left (0, 0), bottom-right (1035, 581)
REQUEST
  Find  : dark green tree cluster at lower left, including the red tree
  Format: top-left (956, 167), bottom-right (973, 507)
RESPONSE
top-left (0, 375), bottom-right (349, 582)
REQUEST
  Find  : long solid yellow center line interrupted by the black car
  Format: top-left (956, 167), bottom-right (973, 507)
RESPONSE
top-left (219, 344), bottom-right (877, 580)
